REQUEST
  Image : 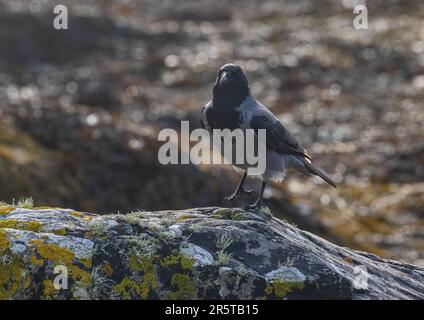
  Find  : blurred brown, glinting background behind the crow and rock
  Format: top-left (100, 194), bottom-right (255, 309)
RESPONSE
top-left (0, 0), bottom-right (424, 265)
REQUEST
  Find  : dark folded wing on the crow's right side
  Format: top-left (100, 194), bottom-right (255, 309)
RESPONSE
top-left (249, 104), bottom-right (312, 161)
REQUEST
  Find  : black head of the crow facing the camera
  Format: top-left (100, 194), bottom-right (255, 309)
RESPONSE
top-left (213, 63), bottom-right (250, 103)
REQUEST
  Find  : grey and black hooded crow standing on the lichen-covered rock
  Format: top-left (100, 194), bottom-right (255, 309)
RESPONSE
top-left (200, 63), bottom-right (336, 209)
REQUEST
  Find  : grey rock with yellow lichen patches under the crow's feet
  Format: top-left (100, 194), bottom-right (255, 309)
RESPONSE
top-left (0, 204), bottom-right (424, 299)
